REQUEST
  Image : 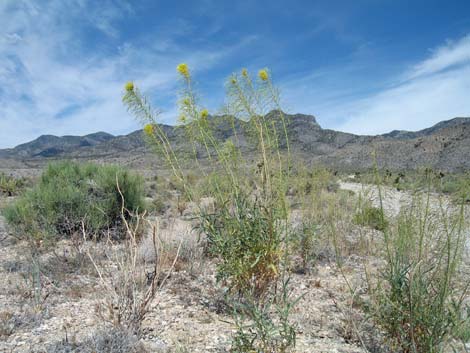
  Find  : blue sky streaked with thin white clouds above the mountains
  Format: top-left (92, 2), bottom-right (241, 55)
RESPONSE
top-left (0, 0), bottom-right (470, 148)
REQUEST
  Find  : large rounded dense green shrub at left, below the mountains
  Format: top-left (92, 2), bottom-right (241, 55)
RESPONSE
top-left (4, 162), bottom-right (143, 240)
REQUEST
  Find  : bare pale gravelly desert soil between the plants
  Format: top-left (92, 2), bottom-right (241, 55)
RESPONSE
top-left (0, 183), bottom-right (468, 353)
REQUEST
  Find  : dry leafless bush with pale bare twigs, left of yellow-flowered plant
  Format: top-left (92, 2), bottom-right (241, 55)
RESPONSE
top-left (82, 197), bottom-right (179, 335)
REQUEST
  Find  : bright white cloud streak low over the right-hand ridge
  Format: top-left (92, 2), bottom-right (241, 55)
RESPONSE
top-left (335, 66), bottom-right (470, 134)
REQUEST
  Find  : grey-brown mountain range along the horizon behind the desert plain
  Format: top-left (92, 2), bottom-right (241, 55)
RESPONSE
top-left (0, 111), bottom-right (470, 172)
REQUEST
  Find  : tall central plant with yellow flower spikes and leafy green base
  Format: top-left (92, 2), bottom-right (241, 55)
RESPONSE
top-left (123, 64), bottom-right (295, 351)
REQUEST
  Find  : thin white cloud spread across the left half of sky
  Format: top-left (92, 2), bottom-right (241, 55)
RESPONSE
top-left (0, 0), bottom-right (252, 148)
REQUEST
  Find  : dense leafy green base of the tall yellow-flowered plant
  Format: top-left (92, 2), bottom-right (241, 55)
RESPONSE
top-left (201, 198), bottom-right (282, 296)
